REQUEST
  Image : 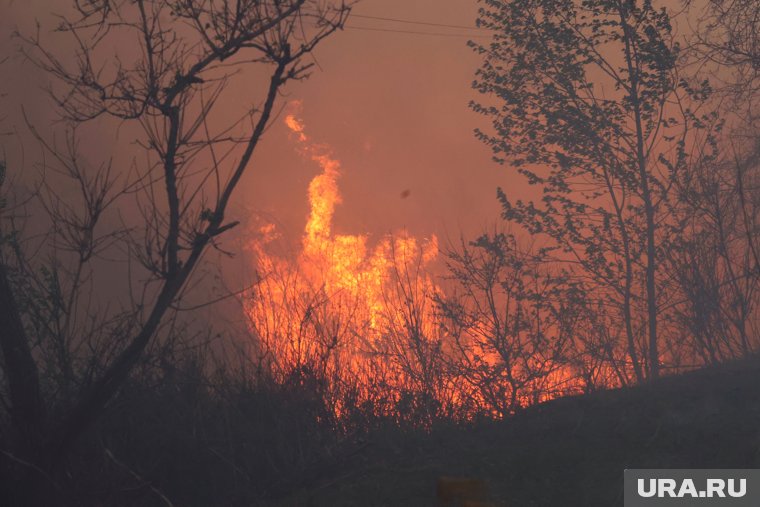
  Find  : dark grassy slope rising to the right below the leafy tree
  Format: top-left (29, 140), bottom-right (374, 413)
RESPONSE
top-left (278, 359), bottom-right (760, 507)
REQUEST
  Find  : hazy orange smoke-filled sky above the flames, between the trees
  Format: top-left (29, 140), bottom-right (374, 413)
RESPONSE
top-left (0, 0), bottom-right (518, 258)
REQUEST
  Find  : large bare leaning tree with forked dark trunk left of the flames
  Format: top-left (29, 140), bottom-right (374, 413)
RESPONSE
top-left (0, 0), bottom-right (350, 500)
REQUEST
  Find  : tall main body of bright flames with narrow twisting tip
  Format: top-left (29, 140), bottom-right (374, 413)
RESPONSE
top-left (246, 103), bottom-right (446, 420)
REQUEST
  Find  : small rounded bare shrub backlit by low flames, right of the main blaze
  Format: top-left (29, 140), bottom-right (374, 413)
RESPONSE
top-left (439, 233), bottom-right (577, 417)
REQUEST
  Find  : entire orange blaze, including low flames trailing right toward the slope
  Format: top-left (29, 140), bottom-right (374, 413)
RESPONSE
top-left (246, 104), bottom-right (588, 424)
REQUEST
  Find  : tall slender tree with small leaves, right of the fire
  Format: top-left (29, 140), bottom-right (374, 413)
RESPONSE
top-left (471, 0), bottom-right (713, 381)
